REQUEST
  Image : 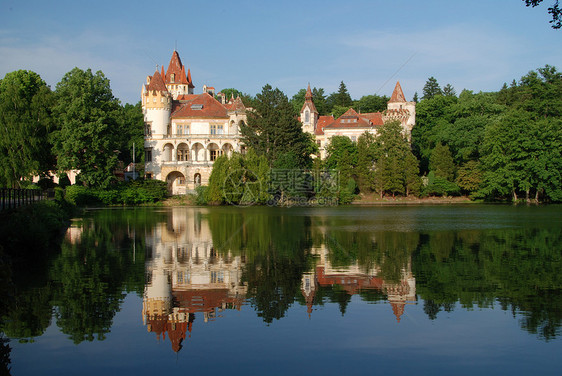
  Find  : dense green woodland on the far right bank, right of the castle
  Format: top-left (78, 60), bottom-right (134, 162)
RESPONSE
top-left (412, 65), bottom-right (562, 202)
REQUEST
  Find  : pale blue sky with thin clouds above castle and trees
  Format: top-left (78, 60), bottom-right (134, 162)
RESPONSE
top-left (0, 0), bottom-right (562, 103)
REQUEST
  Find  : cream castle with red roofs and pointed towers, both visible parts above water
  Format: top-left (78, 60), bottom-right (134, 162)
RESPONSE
top-left (141, 51), bottom-right (416, 194)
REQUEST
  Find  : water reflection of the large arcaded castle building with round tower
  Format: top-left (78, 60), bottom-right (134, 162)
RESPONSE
top-left (142, 208), bottom-right (247, 352)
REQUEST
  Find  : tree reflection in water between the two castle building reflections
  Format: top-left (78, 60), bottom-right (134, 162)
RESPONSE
top-left (208, 208), bottom-right (310, 323)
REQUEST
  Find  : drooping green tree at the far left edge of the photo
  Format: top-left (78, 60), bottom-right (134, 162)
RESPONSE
top-left (0, 70), bottom-right (54, 186)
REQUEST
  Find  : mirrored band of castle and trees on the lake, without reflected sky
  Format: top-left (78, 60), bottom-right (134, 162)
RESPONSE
top-left (0, 206), bottom-right (562, 364)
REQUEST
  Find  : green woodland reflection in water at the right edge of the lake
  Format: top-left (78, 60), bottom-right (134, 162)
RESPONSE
top-left (413, 228), bottom-right (562, 340)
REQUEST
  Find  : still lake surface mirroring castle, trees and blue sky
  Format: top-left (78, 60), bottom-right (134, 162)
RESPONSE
top-left (2, 205), bottom-right (562, 375)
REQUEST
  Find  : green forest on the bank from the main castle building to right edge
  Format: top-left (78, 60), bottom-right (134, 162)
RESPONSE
top-left (203, 65), bottom-right (562, 204)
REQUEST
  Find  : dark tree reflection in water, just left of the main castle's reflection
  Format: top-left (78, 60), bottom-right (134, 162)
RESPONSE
top-left (47, 211), bottom-right (153, 343)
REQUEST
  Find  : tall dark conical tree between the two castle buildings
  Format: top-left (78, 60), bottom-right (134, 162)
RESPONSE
top-left (240, 85), bottom-right (317, 168)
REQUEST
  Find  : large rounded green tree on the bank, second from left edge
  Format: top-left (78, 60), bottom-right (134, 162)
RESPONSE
top-left (53, 68), bottom-right (121, 187)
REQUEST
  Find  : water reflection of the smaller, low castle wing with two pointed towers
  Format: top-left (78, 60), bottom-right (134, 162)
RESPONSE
top-left (301, 245), bottom-right (416, 322)
